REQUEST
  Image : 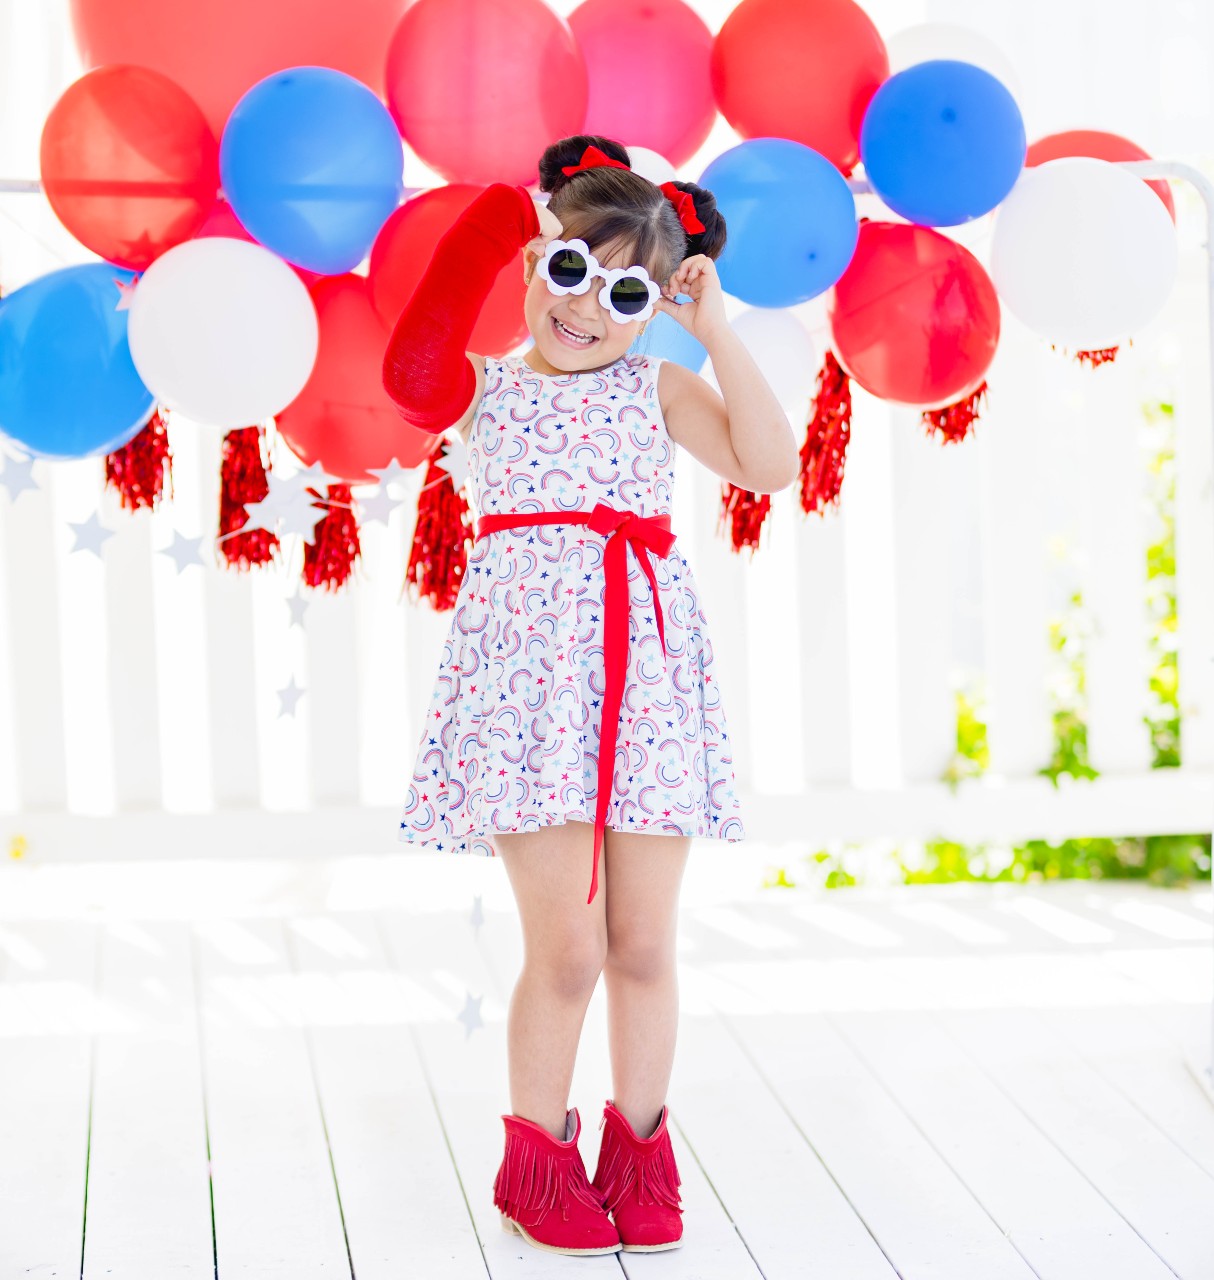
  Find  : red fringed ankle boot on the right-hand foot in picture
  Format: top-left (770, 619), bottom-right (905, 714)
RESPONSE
top-left (592, 1098), bottom-right (683, 1253)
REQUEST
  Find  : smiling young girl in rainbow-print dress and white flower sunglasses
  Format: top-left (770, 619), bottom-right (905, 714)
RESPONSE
top-left (384, 136), bottom-right (798, 1254)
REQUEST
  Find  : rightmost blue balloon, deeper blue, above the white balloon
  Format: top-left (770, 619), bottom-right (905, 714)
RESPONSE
top-left (859, 59), bottom-right (1026, 227)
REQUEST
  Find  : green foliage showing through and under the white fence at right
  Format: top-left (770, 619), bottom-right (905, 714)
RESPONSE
top-left (763, 402), bottom-right (1211, 888)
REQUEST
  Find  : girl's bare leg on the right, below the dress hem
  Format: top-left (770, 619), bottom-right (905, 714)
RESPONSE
top-left (595, 829), bottom-right (692, 1138)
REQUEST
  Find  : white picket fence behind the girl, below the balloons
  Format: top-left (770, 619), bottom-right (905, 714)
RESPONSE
top-left (0, 222), bottom-right (1214, 856)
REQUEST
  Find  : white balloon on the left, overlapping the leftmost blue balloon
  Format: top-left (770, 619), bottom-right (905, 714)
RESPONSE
top-left (127, 236), bottom-right (320, 429)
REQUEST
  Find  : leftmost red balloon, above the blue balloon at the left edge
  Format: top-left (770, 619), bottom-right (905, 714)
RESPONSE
top-left (40, 67), bottom-right (219, 271)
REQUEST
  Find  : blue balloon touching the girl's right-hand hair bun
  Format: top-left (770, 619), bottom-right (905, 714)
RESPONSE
top-left (699, 138), bottom-right (859, 307)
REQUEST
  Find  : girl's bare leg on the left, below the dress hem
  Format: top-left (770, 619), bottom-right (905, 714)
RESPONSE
top-left (493, 822), bottom-right (607, 1142)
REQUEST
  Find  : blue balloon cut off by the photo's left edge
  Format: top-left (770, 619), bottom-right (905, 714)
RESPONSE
top-left (0, 262), bottom-right (155, 458)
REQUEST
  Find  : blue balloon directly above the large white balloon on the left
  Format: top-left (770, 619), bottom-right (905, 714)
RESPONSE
top-left (219, 67), bottom-right (405, 275)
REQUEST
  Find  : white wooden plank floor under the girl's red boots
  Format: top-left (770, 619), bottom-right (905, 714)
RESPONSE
top-left (0, 847), bottom-right (1214, 1280)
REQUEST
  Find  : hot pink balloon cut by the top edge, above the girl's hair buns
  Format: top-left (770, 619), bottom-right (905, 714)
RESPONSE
top-left (569, 0), bottom-right (717, 166)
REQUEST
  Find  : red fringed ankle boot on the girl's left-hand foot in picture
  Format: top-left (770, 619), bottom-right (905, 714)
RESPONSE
top-left (493, 1107), bottom-right (620, 1253)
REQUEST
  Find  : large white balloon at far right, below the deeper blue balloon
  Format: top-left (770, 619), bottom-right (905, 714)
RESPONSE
top-left (991, 156), bottom-right (1177, 351)
